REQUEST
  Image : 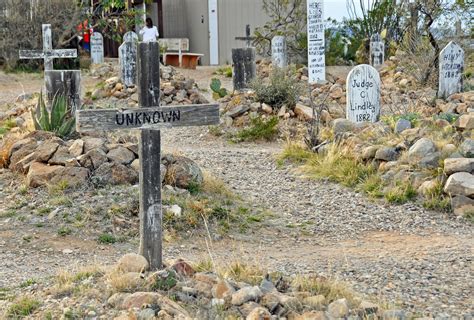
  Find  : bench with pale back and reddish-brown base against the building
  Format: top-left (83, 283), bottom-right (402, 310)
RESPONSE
top-left (159, 38), bottom-right (204, 69)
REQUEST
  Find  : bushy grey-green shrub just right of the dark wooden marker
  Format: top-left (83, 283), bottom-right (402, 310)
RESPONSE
top-left (250, 68), bottom-right (302, 108)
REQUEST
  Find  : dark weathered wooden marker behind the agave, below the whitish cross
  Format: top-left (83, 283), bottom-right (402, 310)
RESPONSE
top-left (44, 70), bottom-right (81, 112)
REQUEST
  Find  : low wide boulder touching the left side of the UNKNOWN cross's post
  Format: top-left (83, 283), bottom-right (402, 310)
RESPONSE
top-left (92, 162), bottom-right (138, 186)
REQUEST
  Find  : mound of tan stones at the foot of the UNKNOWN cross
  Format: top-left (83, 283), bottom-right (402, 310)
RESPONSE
top-left (67, 254), bottom-right (407, 320)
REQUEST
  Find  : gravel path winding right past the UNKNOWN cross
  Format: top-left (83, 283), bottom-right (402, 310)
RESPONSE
top-left (163, 128), bottom-right (474, 316)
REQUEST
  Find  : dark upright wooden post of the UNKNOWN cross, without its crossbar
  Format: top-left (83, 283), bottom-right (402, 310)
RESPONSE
top-left (137, 42), bottom-right (163, 270)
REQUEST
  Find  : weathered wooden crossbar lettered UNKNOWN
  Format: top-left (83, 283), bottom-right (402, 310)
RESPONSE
top-left (76, 104), bottom-right (219, 132)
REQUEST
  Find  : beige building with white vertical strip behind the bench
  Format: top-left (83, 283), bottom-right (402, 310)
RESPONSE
top-left (147, 0), bottom-right (269, 65)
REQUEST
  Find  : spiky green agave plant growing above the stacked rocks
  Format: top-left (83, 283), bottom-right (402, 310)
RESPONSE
top-left (31, 93), bottom-right (76, 138)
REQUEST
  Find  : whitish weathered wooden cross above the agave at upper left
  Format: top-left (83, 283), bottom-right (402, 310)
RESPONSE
top-left (20, 24), bottom-right (77, 71)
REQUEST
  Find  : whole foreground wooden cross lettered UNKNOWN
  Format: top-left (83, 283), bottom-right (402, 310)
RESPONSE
top-left (76, 42), bottom-right (219, 270)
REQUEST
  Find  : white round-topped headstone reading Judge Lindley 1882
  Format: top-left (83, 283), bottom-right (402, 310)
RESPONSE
top-left (346, 64), bottom-right (380, 122)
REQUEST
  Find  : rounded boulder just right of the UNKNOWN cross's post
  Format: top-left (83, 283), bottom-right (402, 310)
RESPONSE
top-left (163, 155), bottom-right (204, 189)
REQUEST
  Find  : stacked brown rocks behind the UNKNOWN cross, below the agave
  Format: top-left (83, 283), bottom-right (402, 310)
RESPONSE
top-left (6, 131), bottom-right (203, 189)
